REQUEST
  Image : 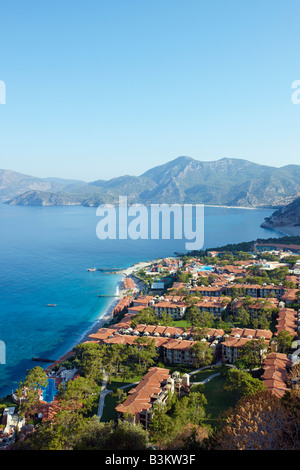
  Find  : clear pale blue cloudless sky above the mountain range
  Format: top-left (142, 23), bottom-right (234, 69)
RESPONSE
top-left (0, 0), bottom-right (300, 181)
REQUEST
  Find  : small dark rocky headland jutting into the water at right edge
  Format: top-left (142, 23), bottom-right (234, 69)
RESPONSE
top-left (261, 197), bottom-right (300, 230)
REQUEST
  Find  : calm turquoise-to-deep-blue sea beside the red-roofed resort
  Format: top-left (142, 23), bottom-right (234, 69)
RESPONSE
top-left (0, 204), bottom-right (283, 397)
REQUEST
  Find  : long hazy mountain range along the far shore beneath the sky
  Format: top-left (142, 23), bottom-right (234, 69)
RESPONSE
top-left (0, 156), bottom-right (300, 207)
